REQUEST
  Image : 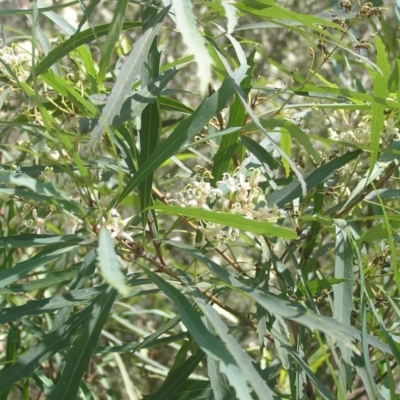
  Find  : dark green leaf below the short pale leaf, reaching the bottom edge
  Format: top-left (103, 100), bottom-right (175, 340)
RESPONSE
top-left (48, 286), bottom-right (117, 400)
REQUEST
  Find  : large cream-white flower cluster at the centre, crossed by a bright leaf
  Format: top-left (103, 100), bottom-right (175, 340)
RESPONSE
top-left (171, 169), bottom-right (281, 245)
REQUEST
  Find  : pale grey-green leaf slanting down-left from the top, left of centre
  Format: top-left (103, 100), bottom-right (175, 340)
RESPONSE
top-left (89, 7), bottom-right (169, 148)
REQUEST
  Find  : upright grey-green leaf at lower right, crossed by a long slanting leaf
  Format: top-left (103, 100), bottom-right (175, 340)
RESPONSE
top-left (333, 219), bottom-right (354, 390)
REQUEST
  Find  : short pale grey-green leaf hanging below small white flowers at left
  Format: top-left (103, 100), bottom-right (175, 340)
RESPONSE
top-left (97, 228), bottom-right (129, 296)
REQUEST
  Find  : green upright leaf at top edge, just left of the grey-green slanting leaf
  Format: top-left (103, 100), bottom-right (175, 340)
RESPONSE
top-left (97, 0), bottom-right (129, 87)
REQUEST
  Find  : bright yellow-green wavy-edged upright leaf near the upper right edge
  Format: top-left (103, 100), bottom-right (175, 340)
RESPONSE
top-left (369, 36), bottom-right (392, 173)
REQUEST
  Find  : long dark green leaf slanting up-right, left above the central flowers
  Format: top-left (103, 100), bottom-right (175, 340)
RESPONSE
top-left (110, 80), bottom-right (235, 208)
